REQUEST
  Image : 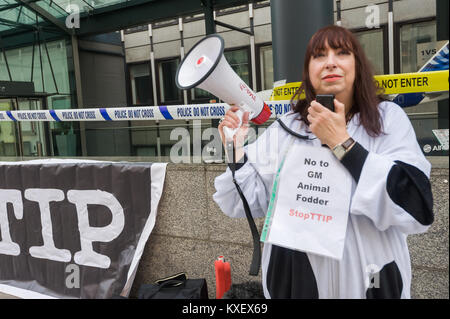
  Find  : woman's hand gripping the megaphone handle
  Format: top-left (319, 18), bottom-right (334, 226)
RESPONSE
top-left (218, 106), bottom-right (250, 158)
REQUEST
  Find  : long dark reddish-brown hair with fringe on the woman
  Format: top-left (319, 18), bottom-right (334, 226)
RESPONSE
top-left (291, 25), bottom-right (384, 136)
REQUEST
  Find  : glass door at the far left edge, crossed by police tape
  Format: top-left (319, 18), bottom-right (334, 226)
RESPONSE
top-left (0, 98), bottom-right (20, 156)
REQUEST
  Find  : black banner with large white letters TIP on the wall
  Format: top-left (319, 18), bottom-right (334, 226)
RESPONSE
top-left (0, 162), bottom-right (165, 298)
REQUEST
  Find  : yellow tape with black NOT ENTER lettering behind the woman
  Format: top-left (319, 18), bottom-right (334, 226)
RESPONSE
top-left (270, 70), bottom-right (448, 101)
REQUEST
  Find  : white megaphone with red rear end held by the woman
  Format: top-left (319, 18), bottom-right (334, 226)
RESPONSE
top-left (175, 34), bottom-right (271, 141)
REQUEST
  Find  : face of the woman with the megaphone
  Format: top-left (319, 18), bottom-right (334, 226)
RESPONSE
top-left (309, 43), bottom-right (355, 97)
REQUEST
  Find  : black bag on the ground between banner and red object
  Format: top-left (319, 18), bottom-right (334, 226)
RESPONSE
top-left (138, 273), bottom-right (208, 299)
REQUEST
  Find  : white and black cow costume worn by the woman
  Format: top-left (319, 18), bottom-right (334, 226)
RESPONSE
top-left (213, 101), bottom-right (434, 298)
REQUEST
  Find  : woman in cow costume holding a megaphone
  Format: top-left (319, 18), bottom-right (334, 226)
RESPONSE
top-left (213, 26), bottom-right (434, 298)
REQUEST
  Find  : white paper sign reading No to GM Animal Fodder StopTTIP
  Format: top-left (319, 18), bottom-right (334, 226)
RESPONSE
top-left (265, 141), bottom-right (352, 259)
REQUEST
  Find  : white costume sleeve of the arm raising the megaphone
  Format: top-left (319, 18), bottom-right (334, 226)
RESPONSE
top-left (213, 123), bottom-right (279, 217)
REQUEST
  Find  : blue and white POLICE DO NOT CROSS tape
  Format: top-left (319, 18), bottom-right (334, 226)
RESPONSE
top-left (0, 101), bottom-right (291, 122)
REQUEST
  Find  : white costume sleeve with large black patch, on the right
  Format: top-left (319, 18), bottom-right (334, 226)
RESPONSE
top-left (343, 103), bottom-right (434, 234)
